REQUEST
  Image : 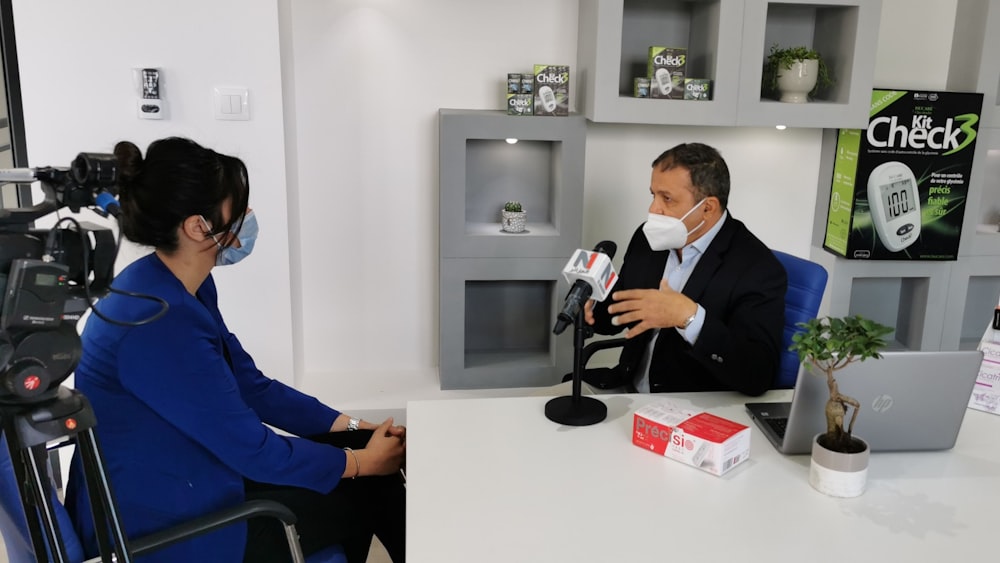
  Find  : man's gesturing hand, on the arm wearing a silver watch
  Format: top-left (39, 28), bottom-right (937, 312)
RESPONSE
top-left (604, 280), bottom-right (698, 338)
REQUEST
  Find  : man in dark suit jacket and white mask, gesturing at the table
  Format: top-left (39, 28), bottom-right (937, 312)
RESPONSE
top-left (586, 143), bottom-right (787, 395)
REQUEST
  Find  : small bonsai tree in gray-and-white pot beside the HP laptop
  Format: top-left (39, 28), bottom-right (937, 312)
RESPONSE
top-left (789, 315), bottom-right (893, 497)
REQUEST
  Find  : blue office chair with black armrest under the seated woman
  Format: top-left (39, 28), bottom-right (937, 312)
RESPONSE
top-left (0, 436), bottom-right (347, 563)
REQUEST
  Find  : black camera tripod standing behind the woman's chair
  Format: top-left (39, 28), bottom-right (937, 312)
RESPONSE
top-left (0, 386), bottom-right (132, 563)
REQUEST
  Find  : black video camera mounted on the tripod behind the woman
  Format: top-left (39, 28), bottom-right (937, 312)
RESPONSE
top-left (0, 153), bottom-right (118, 404)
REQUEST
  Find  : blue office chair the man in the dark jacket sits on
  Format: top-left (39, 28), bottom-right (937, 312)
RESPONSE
top-left (563, 250), bottom-right (827, 390)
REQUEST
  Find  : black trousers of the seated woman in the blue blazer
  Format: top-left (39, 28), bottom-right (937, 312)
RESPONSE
top-left (243, 430), bottom-right (406, 563)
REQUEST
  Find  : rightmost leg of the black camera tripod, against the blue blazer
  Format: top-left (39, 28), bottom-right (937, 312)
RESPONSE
top-left (76, 428), bottom-right (132, 563)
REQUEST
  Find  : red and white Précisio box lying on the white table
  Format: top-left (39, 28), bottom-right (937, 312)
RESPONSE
top-left (632, 401), bottom-right (750, 475)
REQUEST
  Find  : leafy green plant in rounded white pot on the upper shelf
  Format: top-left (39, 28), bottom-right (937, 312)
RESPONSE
top-left (761, 44), bottom-right (834, 103)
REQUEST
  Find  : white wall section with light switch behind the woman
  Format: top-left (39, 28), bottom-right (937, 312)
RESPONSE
top-left (13, 0), bottom-right (293, 381)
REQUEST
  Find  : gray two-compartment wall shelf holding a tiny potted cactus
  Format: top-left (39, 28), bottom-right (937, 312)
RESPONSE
top-left (439, 109), bottom-right (586, 389)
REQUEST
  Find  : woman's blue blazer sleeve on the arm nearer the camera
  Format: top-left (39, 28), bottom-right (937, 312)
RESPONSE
top-left (118, 297), bottom-right (346, 492)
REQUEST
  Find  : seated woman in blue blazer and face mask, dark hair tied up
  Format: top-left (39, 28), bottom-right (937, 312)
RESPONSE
top-left (66, 138), bottom-right (405, 563)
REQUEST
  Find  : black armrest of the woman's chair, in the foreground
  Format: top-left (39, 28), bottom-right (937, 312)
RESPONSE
top-left (129, 500), bottom-right (296, 557)
